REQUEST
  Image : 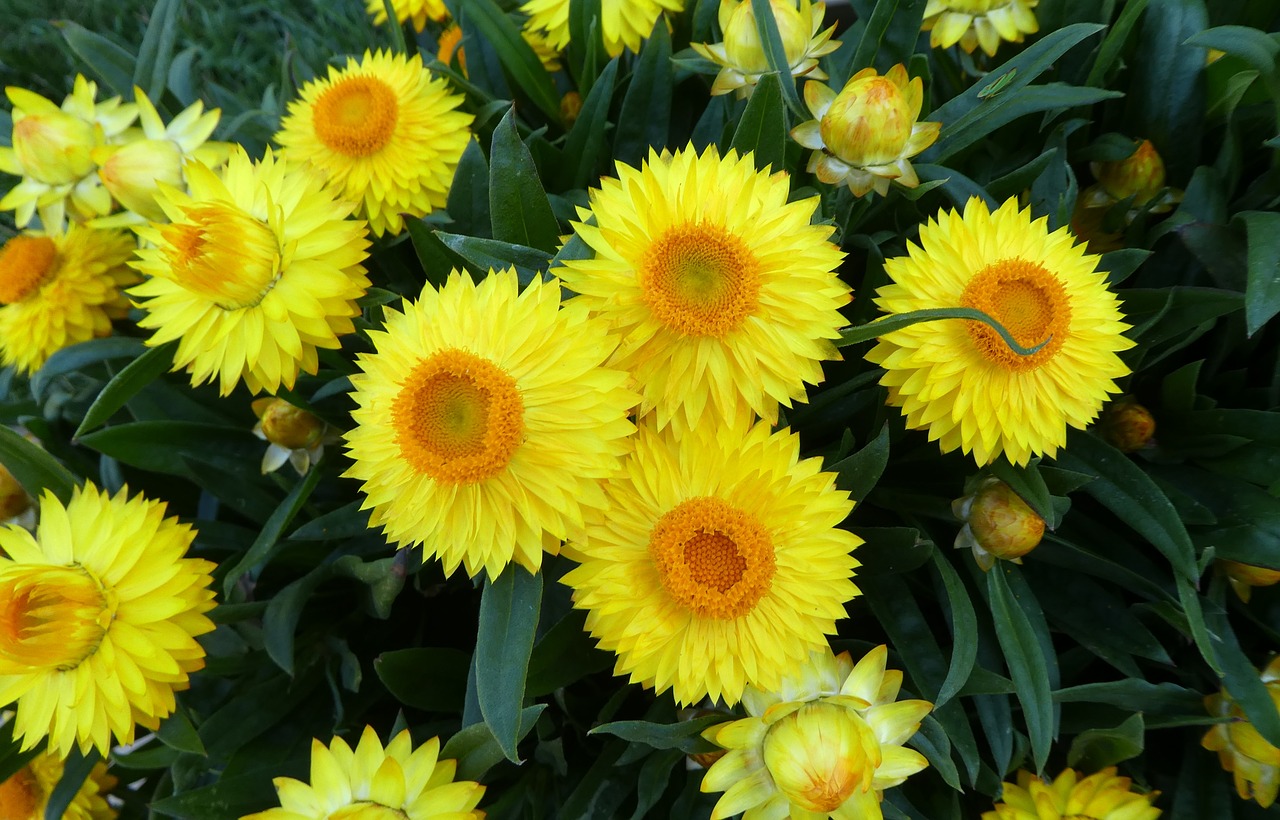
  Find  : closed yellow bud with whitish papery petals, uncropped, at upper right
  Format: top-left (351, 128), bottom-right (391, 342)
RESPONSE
top-left (791, 63), bottom-right (942, 196)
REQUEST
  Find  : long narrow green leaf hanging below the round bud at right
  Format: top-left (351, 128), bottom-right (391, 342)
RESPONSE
top-left (987, 565), bottom-right (1056, 771)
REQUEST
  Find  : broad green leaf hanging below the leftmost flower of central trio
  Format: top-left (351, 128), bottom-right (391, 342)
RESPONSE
top-left (475, 564), bottom-right (543, 762)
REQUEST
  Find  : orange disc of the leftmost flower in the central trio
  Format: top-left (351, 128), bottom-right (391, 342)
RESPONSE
top-left (392, 348), bottom-right (525, 484)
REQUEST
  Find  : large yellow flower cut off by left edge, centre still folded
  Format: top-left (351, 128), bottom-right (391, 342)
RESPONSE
top-left (0, 484), bottom-right (214, 757)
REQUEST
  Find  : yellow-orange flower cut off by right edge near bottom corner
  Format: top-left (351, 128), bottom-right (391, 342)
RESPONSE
top-left (1201, 658), bottom-right (1280, 808)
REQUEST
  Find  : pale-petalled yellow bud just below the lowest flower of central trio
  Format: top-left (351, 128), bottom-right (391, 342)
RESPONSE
top-left (701, 646), bottom-right (933, 820)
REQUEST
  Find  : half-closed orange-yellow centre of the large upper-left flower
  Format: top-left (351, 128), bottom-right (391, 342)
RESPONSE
top-left (160, 202), bottom-right (280, 311)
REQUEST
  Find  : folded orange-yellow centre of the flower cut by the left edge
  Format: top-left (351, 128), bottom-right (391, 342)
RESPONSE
top-left (0, 564), bottom-right (114, 674)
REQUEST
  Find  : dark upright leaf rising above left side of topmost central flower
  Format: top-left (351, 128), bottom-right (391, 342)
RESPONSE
top-left (613, 21), bottom-right (675, 168)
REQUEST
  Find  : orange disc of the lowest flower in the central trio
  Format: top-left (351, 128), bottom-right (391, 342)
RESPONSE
top-left (649, 498), bottom-right (774, 620)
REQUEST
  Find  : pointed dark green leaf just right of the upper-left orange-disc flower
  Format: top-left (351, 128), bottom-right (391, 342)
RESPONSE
top-left (483, 107), bottom-right (559, 253)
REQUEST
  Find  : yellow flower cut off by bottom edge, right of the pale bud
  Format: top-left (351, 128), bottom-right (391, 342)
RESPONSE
top-left (982, 766), bottom-right (1160, 820)
